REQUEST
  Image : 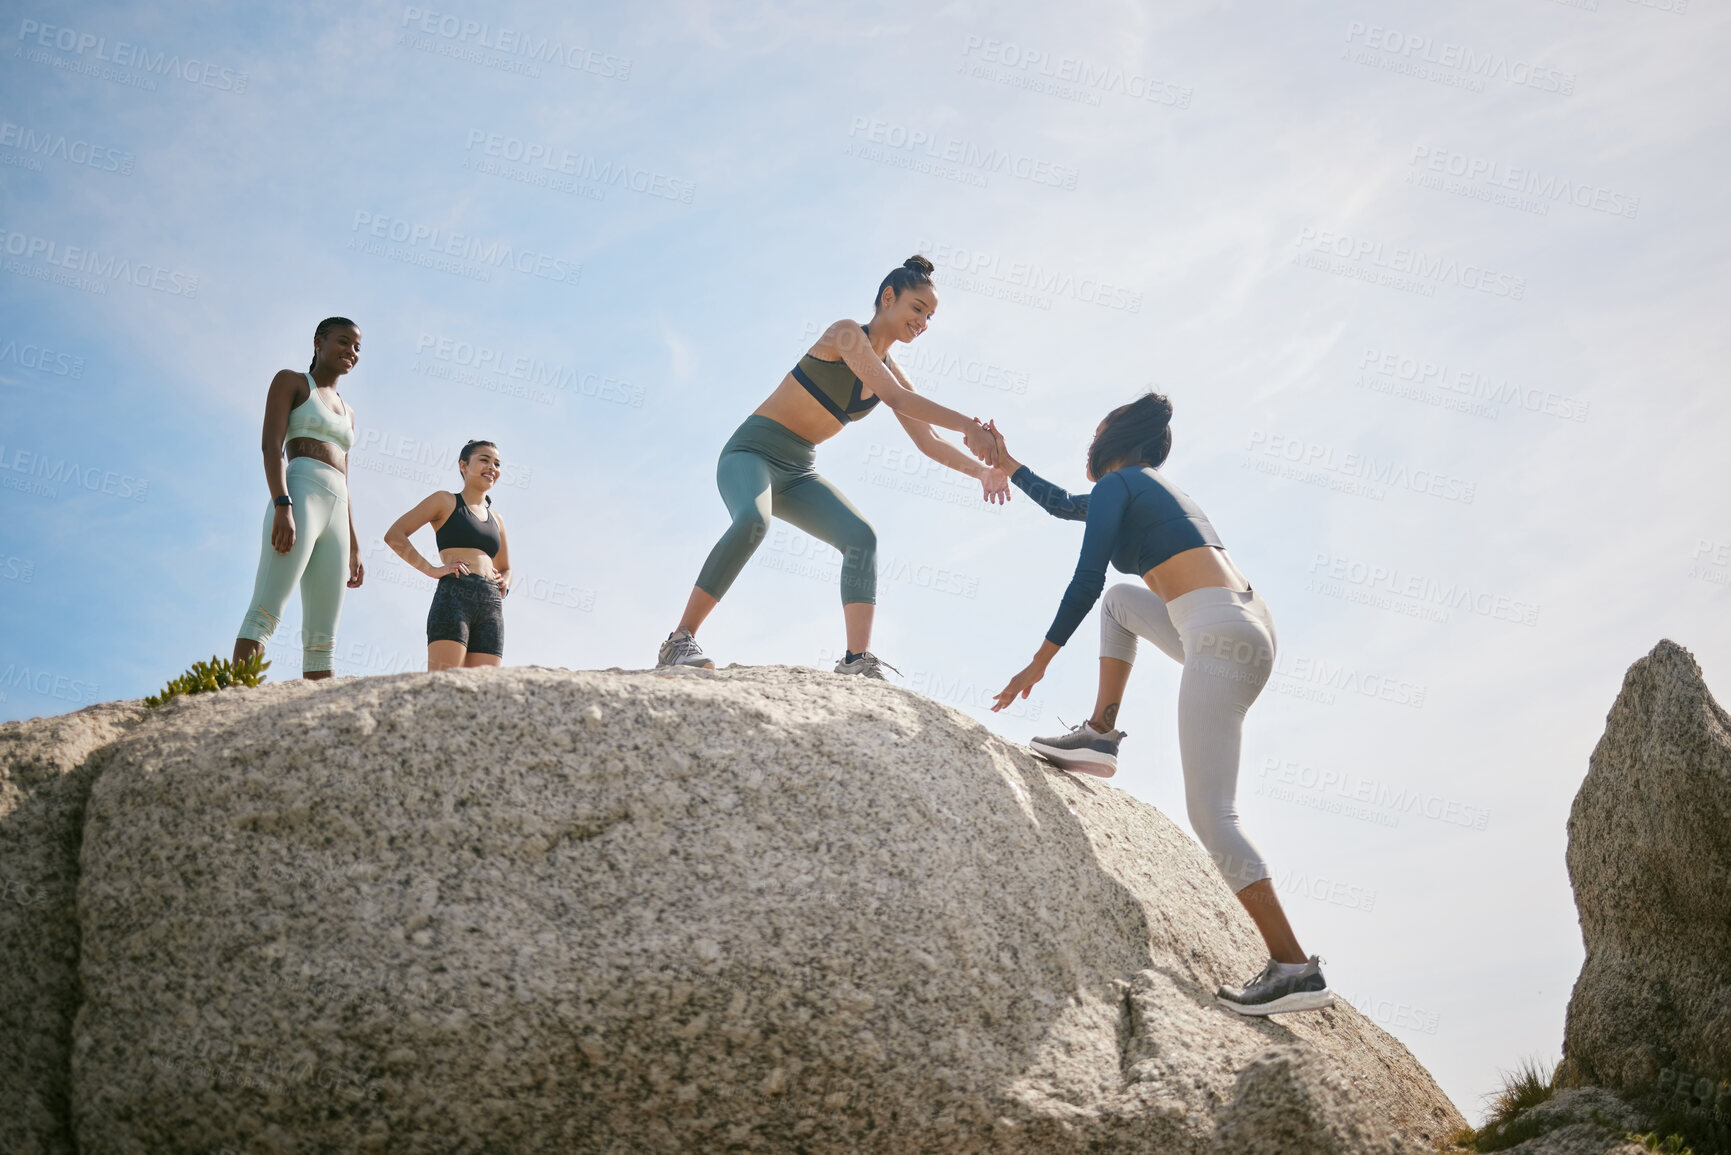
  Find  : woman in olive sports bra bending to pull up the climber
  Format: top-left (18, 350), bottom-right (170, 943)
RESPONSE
top-left (656, 256), bottom-right (1009, 679)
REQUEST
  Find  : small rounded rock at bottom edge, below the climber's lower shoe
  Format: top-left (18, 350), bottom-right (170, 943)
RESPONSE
top-left (1215, 1046), bottom-right (1398, 1155)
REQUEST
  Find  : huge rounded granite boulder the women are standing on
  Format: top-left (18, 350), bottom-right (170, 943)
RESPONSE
top-left (54, 668), bottom-right (1463, 1155)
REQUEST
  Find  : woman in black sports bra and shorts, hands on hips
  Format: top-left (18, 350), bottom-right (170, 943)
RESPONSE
top-left (384, 442), bottom-right (511, 670)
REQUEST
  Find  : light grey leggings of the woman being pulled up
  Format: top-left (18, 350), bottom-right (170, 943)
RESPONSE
top-left (1099, 582), bottom-right (1274, 892)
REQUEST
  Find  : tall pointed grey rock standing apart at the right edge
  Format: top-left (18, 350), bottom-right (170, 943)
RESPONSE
top-left (1563, 641), bottom-right (1731, 1122)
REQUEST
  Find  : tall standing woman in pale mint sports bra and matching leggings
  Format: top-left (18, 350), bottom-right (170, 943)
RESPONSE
top-left (234, 317), bottom-right (364, 679)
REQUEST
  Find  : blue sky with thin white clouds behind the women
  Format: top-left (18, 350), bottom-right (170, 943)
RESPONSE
top-left (0, 0), bottom-right (1731, 1115)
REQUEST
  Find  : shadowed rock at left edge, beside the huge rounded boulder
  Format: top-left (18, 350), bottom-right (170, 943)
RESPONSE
top-left (0, 701), bottom-right (142, 1155)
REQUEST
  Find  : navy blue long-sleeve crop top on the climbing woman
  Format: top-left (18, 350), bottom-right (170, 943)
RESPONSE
top-left (1009, 466), bottom-right (1224, 646)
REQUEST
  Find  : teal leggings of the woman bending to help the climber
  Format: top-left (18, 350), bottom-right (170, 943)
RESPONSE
top-left (698, 414), bottom-right (878, 606)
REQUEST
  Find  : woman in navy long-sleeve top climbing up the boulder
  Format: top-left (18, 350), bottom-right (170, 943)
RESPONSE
top-left (992, 393), bottom-right (1335, 1015)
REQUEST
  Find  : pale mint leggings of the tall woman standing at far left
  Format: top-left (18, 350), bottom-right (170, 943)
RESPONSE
top-left (235, 457), bottom-right (348, 674)
